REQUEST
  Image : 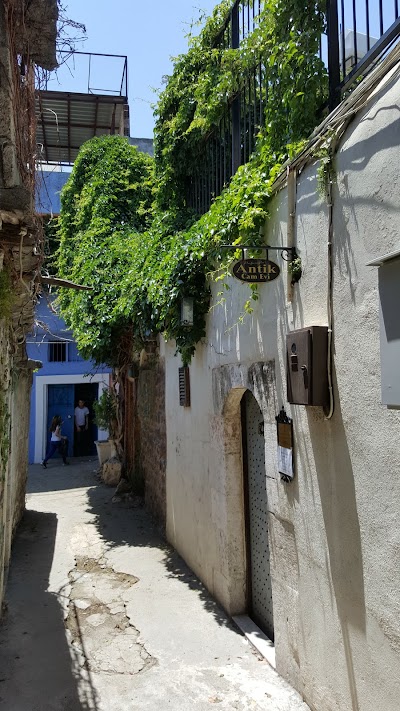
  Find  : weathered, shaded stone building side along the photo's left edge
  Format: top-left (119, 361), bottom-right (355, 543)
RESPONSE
top-left (0, 0), bottom-right (57, 605)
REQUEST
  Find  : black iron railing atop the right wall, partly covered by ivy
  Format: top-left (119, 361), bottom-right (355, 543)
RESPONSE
top-left (187, 0), bottom-right (400, 214)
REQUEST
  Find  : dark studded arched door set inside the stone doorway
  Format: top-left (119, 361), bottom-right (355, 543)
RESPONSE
top-left (241, 390), bottom-right (274, 640)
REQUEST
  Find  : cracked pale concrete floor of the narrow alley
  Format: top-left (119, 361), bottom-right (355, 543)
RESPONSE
top-left (0, 460), bottom-right (308, 711)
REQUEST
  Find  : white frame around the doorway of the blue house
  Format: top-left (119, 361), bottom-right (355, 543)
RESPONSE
top-left (35, 373), bottom-right (109, 464)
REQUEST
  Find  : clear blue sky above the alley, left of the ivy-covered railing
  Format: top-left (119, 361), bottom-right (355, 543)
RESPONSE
top-left (47, 0), bottom-right (218, 138)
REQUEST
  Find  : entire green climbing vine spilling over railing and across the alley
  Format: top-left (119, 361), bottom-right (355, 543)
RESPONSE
top-left (57, 0), bottom-right (326, 366)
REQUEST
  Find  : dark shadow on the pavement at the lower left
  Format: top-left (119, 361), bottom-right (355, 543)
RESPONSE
top-left (0, 511), bottom-right (97, 711)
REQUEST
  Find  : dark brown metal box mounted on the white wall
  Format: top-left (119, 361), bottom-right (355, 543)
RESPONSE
top-left (286, 326), bottom-right (329, 407)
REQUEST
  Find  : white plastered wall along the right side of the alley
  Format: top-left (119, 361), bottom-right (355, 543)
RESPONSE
top-left (165, 67), bottom-right (400, 711)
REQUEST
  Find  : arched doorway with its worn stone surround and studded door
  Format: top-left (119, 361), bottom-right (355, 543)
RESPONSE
top-left (217, 361), bottom-right (276, 641)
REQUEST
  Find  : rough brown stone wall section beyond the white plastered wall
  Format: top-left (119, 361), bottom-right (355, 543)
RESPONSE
top-left (137, 355), bottom-right (166, 527)
